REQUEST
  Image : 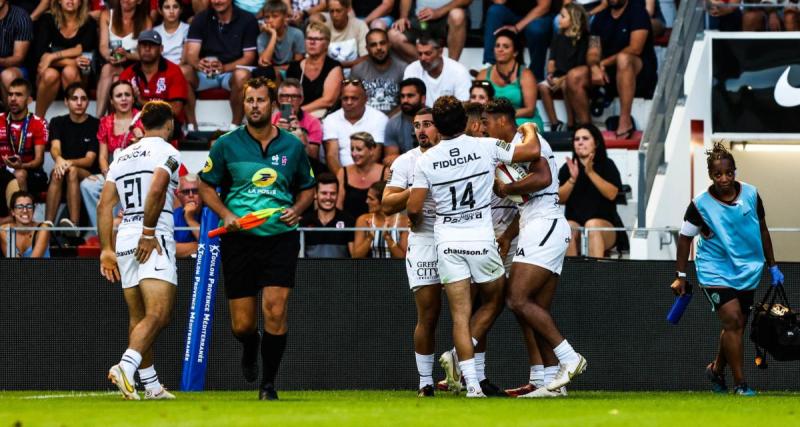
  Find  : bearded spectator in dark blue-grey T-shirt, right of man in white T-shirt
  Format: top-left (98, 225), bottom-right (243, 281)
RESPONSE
top-left (383, 77), bottom-right (425, 166)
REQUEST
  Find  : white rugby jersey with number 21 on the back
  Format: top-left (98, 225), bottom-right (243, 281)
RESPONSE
top-left (106, 137), bottom-right (181, 236)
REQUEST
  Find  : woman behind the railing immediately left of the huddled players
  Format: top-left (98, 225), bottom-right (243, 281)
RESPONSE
top-left (352, 181), bottom-right (409, 259)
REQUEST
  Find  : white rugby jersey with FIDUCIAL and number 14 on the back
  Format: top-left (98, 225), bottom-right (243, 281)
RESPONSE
top-left (412, 135), bottom-right (514, 243)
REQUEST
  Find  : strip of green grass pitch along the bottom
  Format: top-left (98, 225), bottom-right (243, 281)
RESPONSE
top-left (0, 390), bottom-right (800, 427)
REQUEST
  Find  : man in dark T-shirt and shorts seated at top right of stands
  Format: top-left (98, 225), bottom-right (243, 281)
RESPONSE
top-left (566, 0), bottom-right (658, 139)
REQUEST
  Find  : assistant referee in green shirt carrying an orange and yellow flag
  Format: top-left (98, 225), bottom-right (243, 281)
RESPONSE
top-left (199, 78), bottom-right (315, 400)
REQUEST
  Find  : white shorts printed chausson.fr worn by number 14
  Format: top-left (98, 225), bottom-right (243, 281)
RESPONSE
top-left (436, 240), bottom-right (505, 284)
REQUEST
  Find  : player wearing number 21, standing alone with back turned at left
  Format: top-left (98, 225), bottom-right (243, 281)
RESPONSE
top-left (97, 101), bottom-right (181, 400)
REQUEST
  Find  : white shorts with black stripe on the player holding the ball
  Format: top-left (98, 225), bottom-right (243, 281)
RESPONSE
top-left (514, 218), bottom-right (571, 274)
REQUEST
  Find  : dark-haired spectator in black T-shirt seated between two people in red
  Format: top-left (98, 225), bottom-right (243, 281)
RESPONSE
top-left (45, 83), bottom-right (100, 232)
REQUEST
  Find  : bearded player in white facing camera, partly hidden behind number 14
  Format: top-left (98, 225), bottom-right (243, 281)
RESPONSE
top-left (382, 108), bottom-right (442, 397)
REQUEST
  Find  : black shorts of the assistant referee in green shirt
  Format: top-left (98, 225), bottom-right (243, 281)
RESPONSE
top-left (220, 231), bottom-right (300, 299)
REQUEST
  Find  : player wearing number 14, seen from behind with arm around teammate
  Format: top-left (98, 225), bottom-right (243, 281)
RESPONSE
top-left (407, 96), bottom-right (539, 397)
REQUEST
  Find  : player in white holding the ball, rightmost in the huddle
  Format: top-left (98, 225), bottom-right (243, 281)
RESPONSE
top-left (487, 98), bottom-right (586, 397)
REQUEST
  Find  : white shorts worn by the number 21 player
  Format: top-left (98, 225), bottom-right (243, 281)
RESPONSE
top-left (116, 234), bottom-right (178, 289)
